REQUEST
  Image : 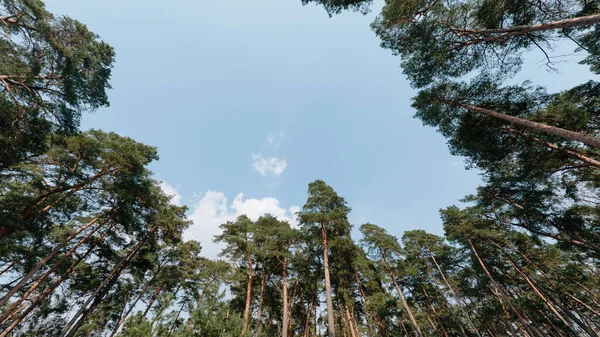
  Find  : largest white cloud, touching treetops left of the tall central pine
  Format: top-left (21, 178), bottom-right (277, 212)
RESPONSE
top-left (184, 191), bottom-right (300, 258)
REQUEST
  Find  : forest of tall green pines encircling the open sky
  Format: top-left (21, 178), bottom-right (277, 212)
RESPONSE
top-left (0, 0), bottom-right (600, 337)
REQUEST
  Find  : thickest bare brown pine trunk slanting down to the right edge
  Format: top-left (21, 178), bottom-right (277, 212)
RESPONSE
top-left (458, 103), bottom-right (600, 148)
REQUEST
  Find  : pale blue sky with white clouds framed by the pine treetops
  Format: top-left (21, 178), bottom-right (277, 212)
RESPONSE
top-left (47, 0), bottom-right (587, 255)
